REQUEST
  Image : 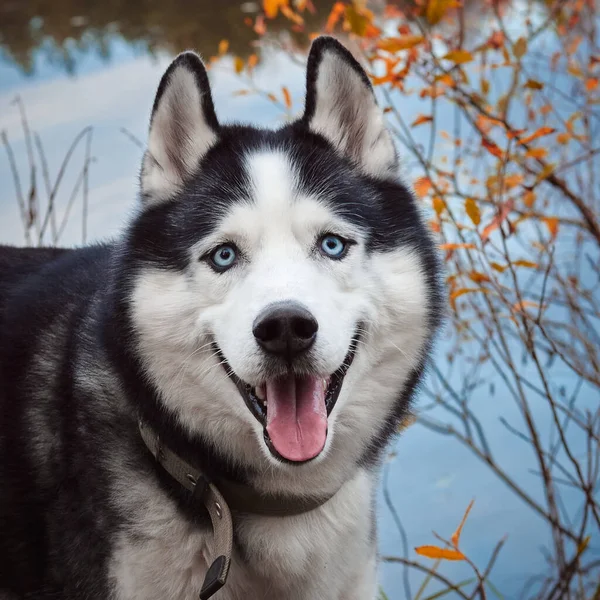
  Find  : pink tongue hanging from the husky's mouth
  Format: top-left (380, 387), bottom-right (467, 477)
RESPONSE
top-left (266, 375), bottom-right (327, 462)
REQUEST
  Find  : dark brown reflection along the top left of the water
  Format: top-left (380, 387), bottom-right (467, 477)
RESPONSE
top-left (0, 0), bottom-right (333, 72)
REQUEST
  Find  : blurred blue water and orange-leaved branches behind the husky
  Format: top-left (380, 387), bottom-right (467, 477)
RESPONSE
top-left (0, 0), bottom-right (600, 600)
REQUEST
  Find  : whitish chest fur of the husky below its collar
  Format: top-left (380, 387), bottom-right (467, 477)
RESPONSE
top-left (109, 471), bottom-right (375, 600)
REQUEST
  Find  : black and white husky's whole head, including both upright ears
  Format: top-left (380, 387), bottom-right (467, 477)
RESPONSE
top-left (122, 38), bottom-right (439, 488)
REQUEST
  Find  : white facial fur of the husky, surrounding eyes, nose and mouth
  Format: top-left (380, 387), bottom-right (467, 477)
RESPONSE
top-left (133, 152), bottom-right (427, 494)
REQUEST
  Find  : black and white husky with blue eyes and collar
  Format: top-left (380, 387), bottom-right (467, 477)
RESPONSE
top-left (0, 38), bottom-right (442, 600)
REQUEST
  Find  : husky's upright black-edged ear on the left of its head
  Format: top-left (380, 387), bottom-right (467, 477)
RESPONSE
top-left (141, 52), bottom-right (219, 204)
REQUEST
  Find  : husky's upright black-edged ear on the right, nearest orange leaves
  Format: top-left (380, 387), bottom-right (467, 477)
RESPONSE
top-left (302, 36), bottom-right (398, 177)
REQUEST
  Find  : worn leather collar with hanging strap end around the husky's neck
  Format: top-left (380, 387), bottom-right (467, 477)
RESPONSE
top-left (138, 419), bottom-right (337, 600)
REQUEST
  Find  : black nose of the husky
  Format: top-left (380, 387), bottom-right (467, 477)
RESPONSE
top-left (252, 302), bottom-right (319, 359)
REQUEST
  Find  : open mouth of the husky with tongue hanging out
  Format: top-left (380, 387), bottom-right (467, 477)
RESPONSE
top-left (216, 336), bottom-right (358, 464)
